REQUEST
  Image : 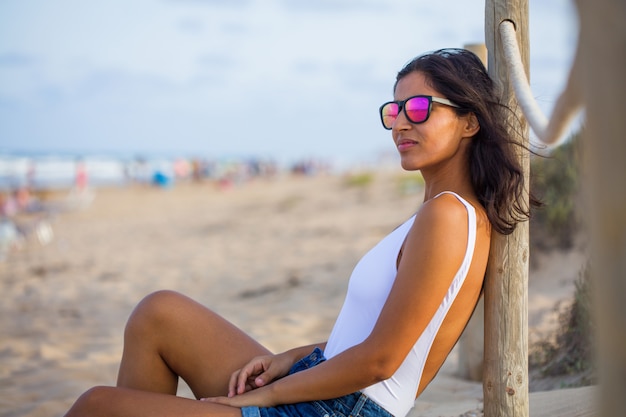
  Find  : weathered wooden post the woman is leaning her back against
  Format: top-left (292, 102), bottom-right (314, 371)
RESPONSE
top-left (483, 0), bottom-right (530, 417)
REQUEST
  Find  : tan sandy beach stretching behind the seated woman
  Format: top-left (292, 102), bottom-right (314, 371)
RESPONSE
top-left (0, 171), bottom-right (595, 417)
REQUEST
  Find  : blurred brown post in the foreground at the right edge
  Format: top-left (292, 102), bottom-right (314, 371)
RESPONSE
top-left (574, 0), bottom-right (626, 417)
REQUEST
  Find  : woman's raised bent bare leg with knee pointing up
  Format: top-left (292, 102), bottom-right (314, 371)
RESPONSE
top-left (118, 291), bottom-right (270, 398)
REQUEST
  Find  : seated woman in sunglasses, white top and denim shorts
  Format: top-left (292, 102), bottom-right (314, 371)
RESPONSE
top-left (67, 49), bottom-right (528, 417)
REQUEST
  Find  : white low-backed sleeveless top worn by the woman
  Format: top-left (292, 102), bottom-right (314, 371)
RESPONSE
top-left (324, 191), bottom-right (476, 417)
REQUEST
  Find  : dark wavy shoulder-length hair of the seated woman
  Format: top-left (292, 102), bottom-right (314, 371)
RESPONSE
top-left (394, 49), bottom-right (540, 234)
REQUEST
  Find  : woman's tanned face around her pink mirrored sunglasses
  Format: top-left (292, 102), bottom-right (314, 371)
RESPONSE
top-left (391, 72), bottom-right (478, 175)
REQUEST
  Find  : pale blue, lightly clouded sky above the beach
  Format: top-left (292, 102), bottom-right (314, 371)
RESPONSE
top-left (0, 0), bottom-right (578, 166)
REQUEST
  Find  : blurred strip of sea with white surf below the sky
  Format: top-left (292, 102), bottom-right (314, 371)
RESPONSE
top-left (0, 149), bottom-right (397, 191)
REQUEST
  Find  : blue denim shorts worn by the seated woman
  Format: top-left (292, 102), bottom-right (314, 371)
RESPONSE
top-left (241, 348), bottom-right (393, 417)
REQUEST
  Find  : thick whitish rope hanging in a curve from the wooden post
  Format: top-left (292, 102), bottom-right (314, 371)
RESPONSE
top-left (499, 20), bottom-right (582, 145)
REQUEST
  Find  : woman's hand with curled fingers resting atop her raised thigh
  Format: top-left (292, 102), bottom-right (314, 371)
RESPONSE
top-left (228, 353), bottom-right (293, 398)
